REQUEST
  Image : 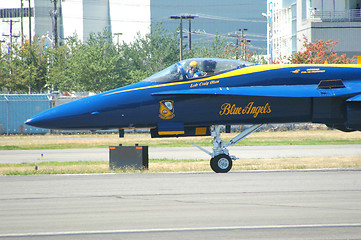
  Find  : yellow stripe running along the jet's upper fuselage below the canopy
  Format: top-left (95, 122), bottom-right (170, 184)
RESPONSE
top-left (106, 64), bottom-right (361, 95)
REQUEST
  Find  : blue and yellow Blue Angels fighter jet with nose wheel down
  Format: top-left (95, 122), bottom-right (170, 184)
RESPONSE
top-left (26, 58), bottom-right (361, 172)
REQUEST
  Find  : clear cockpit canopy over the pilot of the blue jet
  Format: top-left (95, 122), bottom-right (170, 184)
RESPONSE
top-left (144, 58), bottom-right (255, 82)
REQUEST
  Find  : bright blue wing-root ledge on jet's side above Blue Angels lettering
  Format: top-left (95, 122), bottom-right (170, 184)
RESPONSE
top-left (152, 84), bottom-right (360, 98)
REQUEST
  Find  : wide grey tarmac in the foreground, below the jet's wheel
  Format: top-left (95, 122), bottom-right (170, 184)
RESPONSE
top-left (0, 170), bottom-right (361, 240)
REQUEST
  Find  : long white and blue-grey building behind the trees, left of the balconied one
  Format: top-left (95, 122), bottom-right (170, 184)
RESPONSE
top-left (0, 0), bottom-right (266, 52)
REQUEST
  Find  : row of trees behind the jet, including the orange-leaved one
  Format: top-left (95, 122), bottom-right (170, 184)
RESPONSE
top-left (0, 26), bottom-right (349, 93)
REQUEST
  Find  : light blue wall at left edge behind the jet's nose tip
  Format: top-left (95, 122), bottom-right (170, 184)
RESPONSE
top-left (0, 94), bottom-right (51, 134)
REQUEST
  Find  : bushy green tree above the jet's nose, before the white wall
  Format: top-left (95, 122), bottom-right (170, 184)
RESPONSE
top-left (49, 31), bottom-right (125, 93)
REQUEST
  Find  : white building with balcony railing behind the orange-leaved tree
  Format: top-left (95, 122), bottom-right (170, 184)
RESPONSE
top-left (266, 0), bottom-right (361, 60)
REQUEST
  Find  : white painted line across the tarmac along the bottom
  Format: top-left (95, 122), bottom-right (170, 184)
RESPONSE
top-left (0, 223), bottom-right (361, 238)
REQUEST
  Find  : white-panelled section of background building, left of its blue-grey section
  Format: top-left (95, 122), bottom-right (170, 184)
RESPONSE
top-left (0, 0), bottom-right (151, 46)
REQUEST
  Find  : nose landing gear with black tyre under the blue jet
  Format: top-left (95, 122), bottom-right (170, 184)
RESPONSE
top-left (192, 124), bottom-right (262, 173)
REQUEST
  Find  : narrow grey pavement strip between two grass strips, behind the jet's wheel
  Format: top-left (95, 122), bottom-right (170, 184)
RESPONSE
top-left (0, 144), bottom-right (361, 163)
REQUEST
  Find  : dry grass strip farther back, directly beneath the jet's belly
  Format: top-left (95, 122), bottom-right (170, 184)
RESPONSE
top-left (0, 130), bottom-right (361, 150)
